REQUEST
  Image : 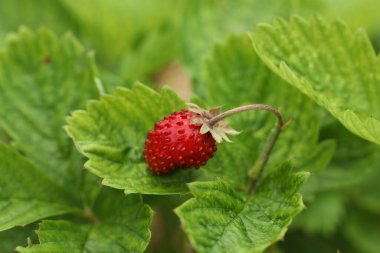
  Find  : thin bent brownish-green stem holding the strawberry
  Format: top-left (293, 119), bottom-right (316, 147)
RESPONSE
top-left (208, 104), bottom-right (286, 194)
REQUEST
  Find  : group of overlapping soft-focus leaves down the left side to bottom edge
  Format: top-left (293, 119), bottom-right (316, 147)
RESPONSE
top-left (0, 28), bottom-right (152, 252)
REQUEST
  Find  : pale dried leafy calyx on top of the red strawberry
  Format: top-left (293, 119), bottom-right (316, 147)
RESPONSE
top-left (187, 103), bottom-right (241, 143)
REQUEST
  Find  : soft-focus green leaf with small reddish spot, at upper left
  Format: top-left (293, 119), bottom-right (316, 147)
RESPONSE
top-left (0, 28), bottom-right (97, 188)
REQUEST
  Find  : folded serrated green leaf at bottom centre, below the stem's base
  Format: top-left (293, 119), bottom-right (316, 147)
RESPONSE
top-left (176, 163), bottom-right (307, 253)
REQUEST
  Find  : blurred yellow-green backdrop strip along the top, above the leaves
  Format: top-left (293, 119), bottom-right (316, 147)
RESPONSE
top-left (0, 0), bottom-right (380, 91)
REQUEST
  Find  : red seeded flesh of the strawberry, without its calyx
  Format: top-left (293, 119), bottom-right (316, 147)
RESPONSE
top-left (144, 110), bottom-right (217, 174)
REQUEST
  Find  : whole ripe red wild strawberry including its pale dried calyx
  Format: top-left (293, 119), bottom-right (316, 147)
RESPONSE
top-left (144, 104), bottom-right (237, 175)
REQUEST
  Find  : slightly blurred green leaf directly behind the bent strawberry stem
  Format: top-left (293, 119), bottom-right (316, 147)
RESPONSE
top-left (202, 35), bottom-right (335, 185)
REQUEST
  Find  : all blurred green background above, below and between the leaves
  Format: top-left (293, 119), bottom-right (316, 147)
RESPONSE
top-left (0, 0), bottom-right (380, 253)
